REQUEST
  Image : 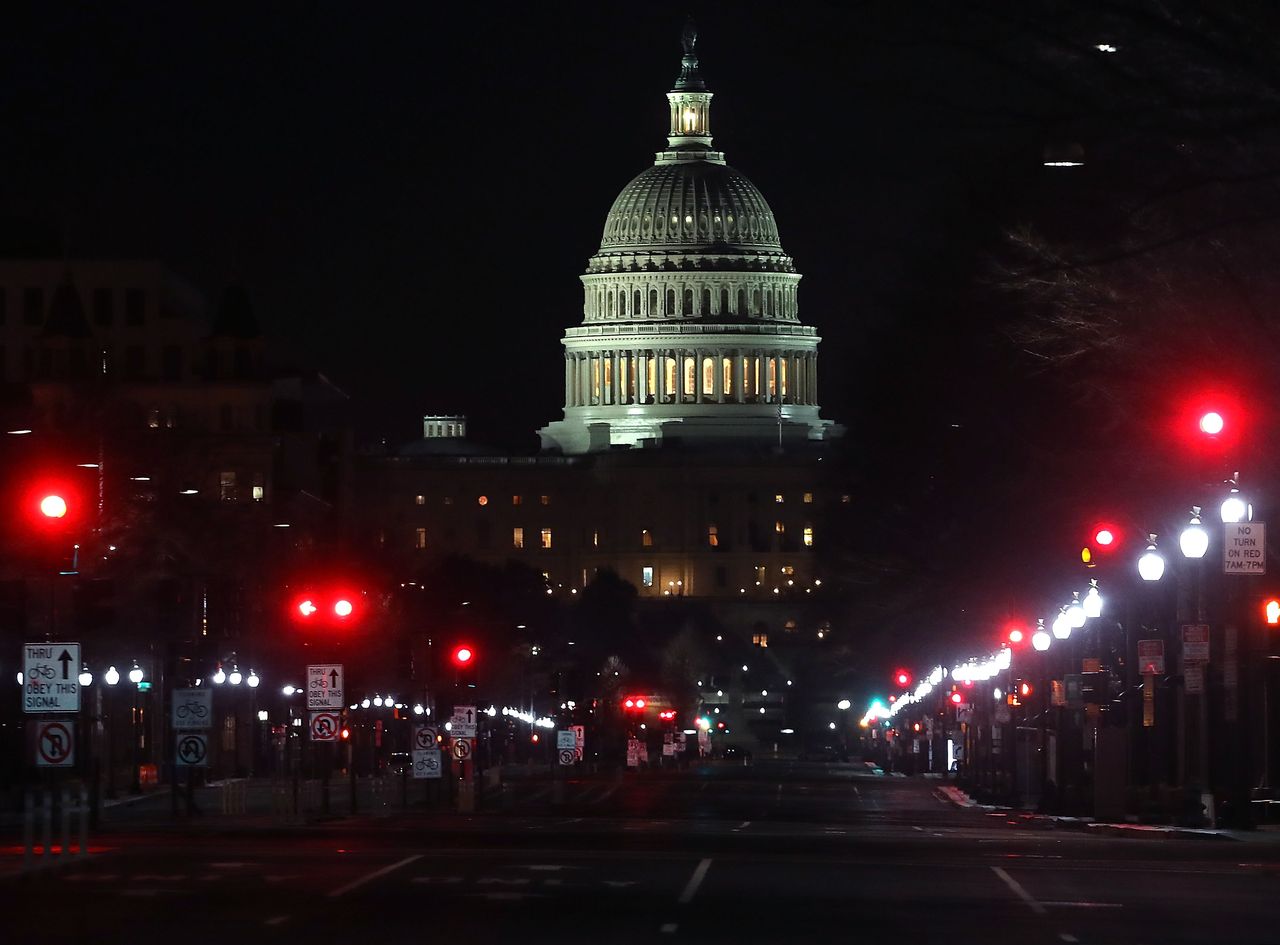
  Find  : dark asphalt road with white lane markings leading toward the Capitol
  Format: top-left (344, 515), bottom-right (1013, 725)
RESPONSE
top-left (0, 763), bottom-right (1280, 945)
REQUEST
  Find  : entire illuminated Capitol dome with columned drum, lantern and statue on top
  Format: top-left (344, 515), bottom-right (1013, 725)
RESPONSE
top-left (539, 24), bottom-right (840, 453)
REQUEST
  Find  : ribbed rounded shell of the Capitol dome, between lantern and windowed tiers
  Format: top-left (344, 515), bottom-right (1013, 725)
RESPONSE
top-left (600, 160), bottom-right (782, 255)
